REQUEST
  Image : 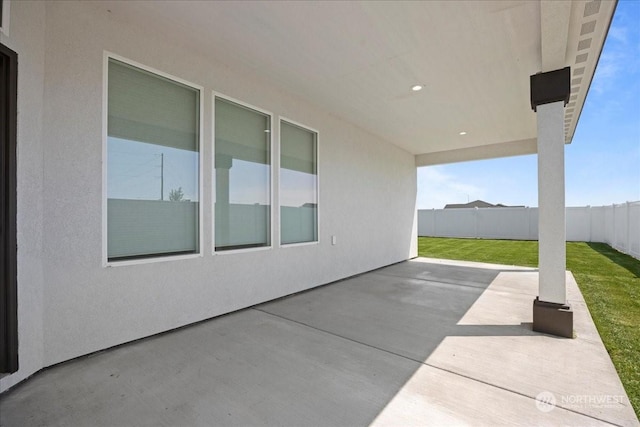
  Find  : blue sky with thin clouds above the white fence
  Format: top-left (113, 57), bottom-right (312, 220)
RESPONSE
top-left (417, 0), bottom-right (640, 209)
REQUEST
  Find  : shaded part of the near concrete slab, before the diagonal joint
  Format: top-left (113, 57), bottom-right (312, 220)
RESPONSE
top-left (0, 310), bottom-right (419, 426)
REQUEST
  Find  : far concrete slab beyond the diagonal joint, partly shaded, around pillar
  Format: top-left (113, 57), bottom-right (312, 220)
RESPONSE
top-left (260, 259), bottom-right (638, 425)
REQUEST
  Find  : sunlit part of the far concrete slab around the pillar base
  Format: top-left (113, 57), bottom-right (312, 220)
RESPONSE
top-left (425, 272), bottom-right (630, 424)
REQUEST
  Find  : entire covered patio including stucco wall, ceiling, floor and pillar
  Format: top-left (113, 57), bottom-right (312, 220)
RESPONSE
top-left (0, 0), bottom-right (637, 426)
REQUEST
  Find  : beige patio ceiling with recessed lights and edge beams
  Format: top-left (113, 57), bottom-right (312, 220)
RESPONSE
top-left (97, 1), bottom-right (615, 166)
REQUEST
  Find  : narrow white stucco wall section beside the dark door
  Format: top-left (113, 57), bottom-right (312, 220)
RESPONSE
top-left (0, 1), bottom-right (45, 391)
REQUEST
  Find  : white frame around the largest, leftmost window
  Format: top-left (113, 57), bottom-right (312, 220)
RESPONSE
top-left (102, 50), bottom-right (205, 267)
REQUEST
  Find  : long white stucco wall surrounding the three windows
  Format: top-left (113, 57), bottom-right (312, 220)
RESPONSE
top-left (0, 2), bottom-right (417, 390)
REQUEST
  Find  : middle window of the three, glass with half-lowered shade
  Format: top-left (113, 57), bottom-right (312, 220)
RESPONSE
top-left (214, 97), bottom-right (271, 251)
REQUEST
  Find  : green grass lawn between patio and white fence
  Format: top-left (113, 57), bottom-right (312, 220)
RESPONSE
top-left (418, 237), bottom-right (640, 418)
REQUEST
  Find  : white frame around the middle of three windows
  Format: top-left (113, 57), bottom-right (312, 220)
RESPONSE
top-left (209, 90), bottom-right (276, 255)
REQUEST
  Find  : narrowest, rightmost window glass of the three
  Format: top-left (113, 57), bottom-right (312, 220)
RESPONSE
top-left (280, 120), bottom-right (318, 245)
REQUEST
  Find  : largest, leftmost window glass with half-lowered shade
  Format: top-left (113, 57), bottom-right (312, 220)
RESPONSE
top-left (106, 58), bottom-right (200, 261)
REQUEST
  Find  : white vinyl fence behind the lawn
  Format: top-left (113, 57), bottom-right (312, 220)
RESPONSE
top-left (418, 201), bottom-right (640, 259)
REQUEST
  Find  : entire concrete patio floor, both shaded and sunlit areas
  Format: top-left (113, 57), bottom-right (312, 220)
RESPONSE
top-left (0, 258), bottom-right (638, 426)
